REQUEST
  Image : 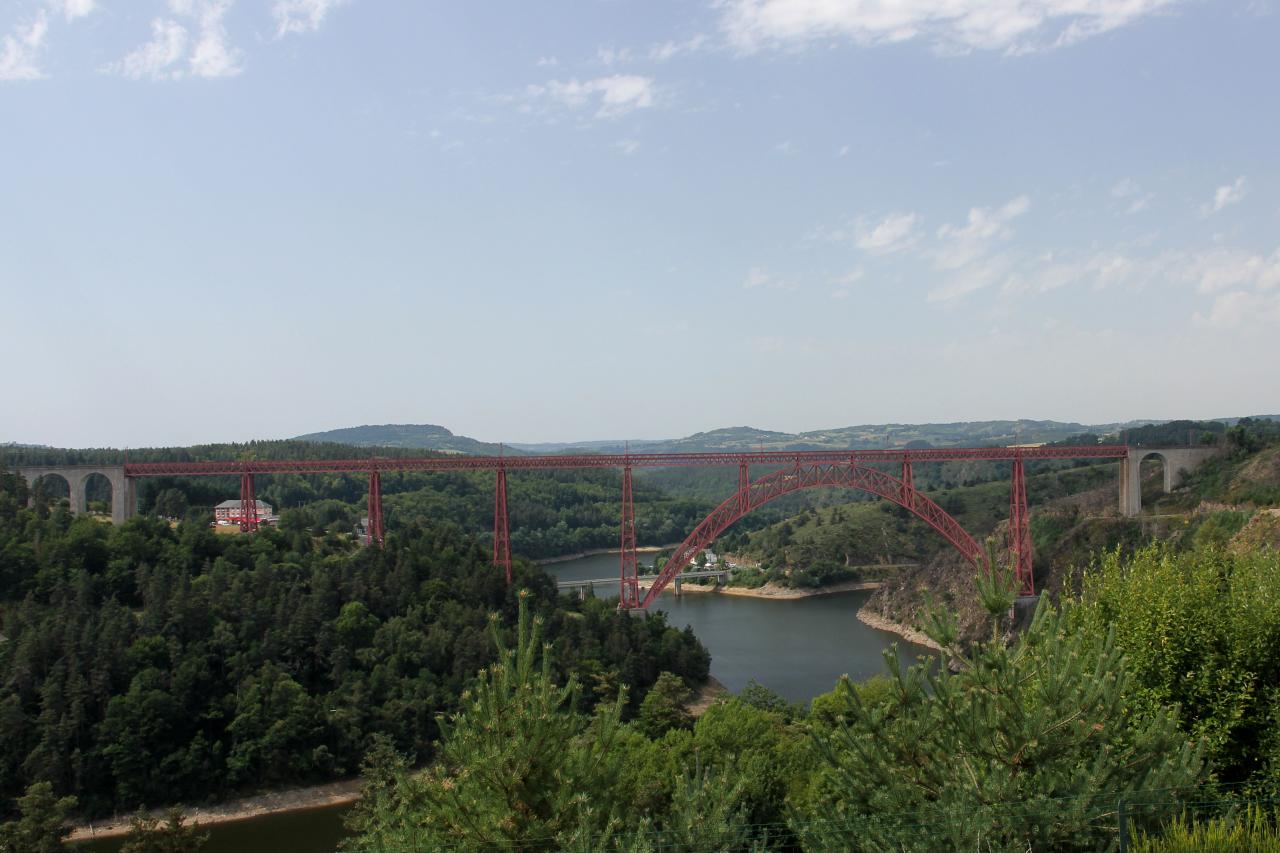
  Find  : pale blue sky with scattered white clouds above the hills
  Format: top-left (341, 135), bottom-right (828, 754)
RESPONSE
top-left (0, 0), bottom-right (1280, 447)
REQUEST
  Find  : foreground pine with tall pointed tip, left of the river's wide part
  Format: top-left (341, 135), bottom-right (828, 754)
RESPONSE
top-left (349, 593), bottom-right (625, 850)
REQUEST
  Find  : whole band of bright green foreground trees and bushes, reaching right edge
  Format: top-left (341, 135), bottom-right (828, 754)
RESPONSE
top-left (348, 535), bottom-right (1280, 852)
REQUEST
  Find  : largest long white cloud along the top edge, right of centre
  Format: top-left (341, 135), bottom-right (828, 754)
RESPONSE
top-left (717, 0), bottom-right (1175, 53)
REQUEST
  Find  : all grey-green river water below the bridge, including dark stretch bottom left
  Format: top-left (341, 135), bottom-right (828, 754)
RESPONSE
top-left (76, 553), bottom-right (931, 853)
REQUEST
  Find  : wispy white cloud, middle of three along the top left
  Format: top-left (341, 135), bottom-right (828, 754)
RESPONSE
top-left (102, 0), bottom-right (243, 79)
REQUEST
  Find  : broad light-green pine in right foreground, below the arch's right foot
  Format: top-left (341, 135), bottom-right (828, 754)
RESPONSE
top-left (792, 555), bottom-right (1203, 852)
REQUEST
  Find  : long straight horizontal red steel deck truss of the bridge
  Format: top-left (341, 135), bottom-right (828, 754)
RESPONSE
top-left (124, 444), bottom-right (1129, 476)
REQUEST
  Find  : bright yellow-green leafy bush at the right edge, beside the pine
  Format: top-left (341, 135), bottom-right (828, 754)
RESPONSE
top-left (1070, 546), bottom-right (1280, 793)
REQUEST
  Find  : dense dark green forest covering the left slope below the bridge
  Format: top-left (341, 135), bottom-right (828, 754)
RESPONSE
top-left (0, 470), bottom-right (709, 815)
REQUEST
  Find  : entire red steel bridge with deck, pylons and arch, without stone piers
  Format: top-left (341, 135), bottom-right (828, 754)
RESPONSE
top-left (110, 444), bottom-right (1130, 610)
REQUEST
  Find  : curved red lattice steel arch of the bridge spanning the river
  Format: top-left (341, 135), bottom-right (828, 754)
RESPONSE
top-left (634, 462), bottom-right (983, 610)
